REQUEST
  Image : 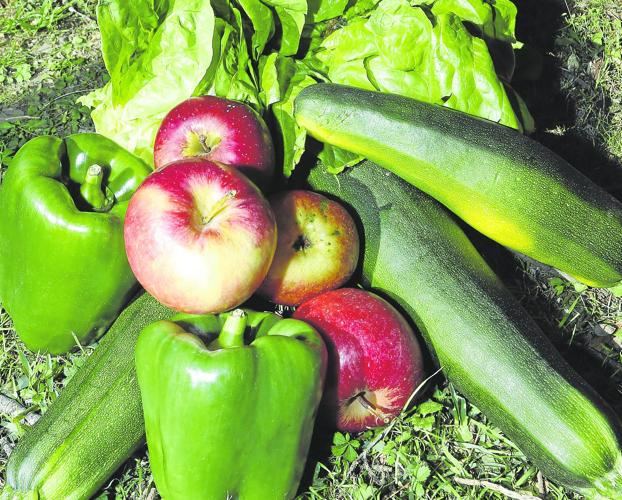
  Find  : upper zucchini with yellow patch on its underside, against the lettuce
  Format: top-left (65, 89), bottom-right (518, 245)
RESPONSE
top-left (295, 84), bottom-right (622, 287)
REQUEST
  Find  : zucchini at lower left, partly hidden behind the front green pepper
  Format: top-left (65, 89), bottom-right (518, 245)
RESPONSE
top-left (0, 293), bottom-right (172, 500)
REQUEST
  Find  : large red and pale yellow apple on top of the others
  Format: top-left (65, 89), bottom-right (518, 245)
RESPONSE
top-left (124, 159), bottom-right (276, 313)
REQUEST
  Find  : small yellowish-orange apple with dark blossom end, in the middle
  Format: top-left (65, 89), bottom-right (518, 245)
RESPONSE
top-left (259, 190), bottom-right (359, 306)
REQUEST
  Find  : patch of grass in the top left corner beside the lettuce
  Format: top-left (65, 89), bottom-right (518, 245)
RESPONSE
top-left (0, 0), bottom-right (106, 167)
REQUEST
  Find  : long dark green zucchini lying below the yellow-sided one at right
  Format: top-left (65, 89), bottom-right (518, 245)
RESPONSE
top-left (308, 162), bottom-right (622, 498)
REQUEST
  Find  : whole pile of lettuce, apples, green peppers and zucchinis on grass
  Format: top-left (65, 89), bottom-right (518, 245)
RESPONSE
top-left (0, 0), bottom-right (622, 499)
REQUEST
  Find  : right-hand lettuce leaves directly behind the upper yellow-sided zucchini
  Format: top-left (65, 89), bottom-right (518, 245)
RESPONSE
top-left (316, 0), bottom-right (533, 172)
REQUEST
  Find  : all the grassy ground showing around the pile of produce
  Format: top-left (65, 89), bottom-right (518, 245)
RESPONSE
top-left (0, 0), bottom-right (622, 499)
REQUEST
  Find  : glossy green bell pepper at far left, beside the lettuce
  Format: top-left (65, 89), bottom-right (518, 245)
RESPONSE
top-left (0, 134), bottom-right (151, 354)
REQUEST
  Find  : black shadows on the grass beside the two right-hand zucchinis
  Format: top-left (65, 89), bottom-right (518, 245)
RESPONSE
top-left (490, 0), bottom-right (622, 415)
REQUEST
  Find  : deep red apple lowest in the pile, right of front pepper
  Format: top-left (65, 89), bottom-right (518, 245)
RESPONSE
top-left (294, 288), bottom-right (423, 432)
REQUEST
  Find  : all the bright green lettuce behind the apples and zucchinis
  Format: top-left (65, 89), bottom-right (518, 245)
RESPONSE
top-left (81, 0), bottom-right (533, 176)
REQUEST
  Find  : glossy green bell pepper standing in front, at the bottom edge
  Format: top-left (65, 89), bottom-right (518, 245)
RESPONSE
top-left (136, 309), bottom-right (326, 500)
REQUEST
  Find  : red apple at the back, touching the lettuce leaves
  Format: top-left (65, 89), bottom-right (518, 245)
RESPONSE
top-left (153, 96), bottom-right (274, 186)
